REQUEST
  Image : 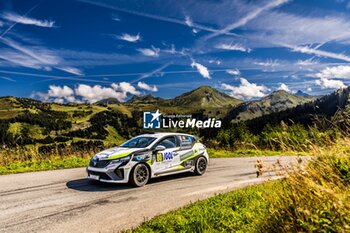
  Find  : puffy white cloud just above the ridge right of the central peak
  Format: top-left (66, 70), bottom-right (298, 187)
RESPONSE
top-left (221, 78), bottom-right (269, 99)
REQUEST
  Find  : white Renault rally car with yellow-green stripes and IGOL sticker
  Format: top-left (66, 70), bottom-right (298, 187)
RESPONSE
top-left (86, 133), bottom-right (209, 187)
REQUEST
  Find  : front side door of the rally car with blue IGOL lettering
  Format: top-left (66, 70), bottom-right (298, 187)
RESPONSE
top-left (152, 136), bottom-right (180, 175)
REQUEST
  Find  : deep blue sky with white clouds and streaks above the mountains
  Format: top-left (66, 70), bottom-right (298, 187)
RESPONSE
top-left (0, 0), bottom-right (350, 103)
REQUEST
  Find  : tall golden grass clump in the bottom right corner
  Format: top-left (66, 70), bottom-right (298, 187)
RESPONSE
top-left (261, 146), bottom-right (350, 232)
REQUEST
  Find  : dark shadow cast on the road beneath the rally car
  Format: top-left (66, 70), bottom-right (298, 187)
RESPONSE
top-left (66, 173), bottom-right (196, 192)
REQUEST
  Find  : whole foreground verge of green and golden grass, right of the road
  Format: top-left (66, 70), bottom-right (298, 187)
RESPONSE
top-left (128, 140), bottom-right (350, 233)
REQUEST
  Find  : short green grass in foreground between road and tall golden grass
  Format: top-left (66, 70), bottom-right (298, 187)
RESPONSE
top-left (127, 182), bottom-right (280, 233)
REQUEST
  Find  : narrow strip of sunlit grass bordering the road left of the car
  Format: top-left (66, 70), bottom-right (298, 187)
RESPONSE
top-left (0, 156), bottom-right (90, 175)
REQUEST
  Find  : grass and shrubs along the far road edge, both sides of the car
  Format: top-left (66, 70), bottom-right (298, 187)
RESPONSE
top-left (0, 112), bottom-right (347, 174)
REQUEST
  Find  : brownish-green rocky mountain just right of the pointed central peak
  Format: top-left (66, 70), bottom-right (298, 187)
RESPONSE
top-left (226, 90), bottom-right (315, 122)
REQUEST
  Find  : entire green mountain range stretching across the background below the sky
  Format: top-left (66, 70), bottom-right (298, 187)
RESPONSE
top-left (0, 87), bottom-right (350, 153)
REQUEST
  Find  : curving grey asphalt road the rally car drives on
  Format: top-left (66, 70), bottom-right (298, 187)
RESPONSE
top-left (0, 157), bottom-right (304, 233)
